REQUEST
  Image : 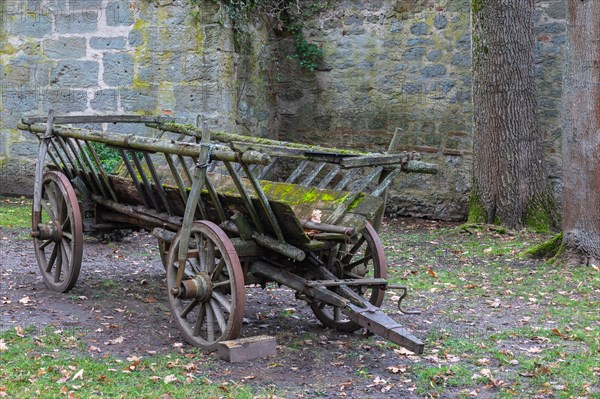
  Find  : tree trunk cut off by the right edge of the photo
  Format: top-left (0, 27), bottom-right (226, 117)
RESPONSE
top-left (563, 0), bottom-right (600, 262)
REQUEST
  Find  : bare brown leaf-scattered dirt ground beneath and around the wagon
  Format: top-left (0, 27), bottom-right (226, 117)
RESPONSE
top-left (0, 222), bottom-right (596, 398)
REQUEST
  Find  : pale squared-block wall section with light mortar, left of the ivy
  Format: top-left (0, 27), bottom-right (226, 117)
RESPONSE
top-left (0, 0), bottom-right (273, 194)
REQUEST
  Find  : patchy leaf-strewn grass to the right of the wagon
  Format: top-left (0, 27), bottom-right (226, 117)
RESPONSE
top-left (382, 220), bottom-right (600, 399)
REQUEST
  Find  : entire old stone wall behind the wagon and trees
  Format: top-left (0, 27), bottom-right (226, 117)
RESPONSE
top-left (0, 0), bottom-right (565, 220)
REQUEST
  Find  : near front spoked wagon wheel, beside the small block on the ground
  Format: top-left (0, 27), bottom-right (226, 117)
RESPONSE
top-left (167, 221), bottom-right (246, 351)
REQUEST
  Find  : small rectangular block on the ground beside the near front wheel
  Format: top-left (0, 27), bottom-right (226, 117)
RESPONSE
top-left (218, 335), bottom-right (277, 363)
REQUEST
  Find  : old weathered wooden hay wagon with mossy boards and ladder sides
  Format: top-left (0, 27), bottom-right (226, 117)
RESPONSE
top-left (18, 112), bottom-right (435, 353)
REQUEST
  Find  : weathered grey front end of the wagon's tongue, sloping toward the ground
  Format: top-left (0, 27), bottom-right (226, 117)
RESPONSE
top-left (344, 302), bottom-right (424, 355)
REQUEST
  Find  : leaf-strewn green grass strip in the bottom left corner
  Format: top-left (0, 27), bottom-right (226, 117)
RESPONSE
top-left (0, 330), bottom-right (274, 399)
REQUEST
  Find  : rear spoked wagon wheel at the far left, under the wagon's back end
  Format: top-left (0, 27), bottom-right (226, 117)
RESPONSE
top-left (32, 171), bottom-right (83, 292)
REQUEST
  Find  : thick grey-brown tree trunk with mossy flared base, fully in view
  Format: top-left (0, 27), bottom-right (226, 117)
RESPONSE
top-left (469, 0), bottom-right (558, 230)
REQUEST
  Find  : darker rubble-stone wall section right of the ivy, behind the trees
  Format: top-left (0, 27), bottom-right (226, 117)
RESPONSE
top-left (276, 0), bottom-right (565, 219)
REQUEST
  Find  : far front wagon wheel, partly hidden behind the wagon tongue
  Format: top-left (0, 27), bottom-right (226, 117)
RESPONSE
top-left (310, 222), bottom-right (387, 332)
